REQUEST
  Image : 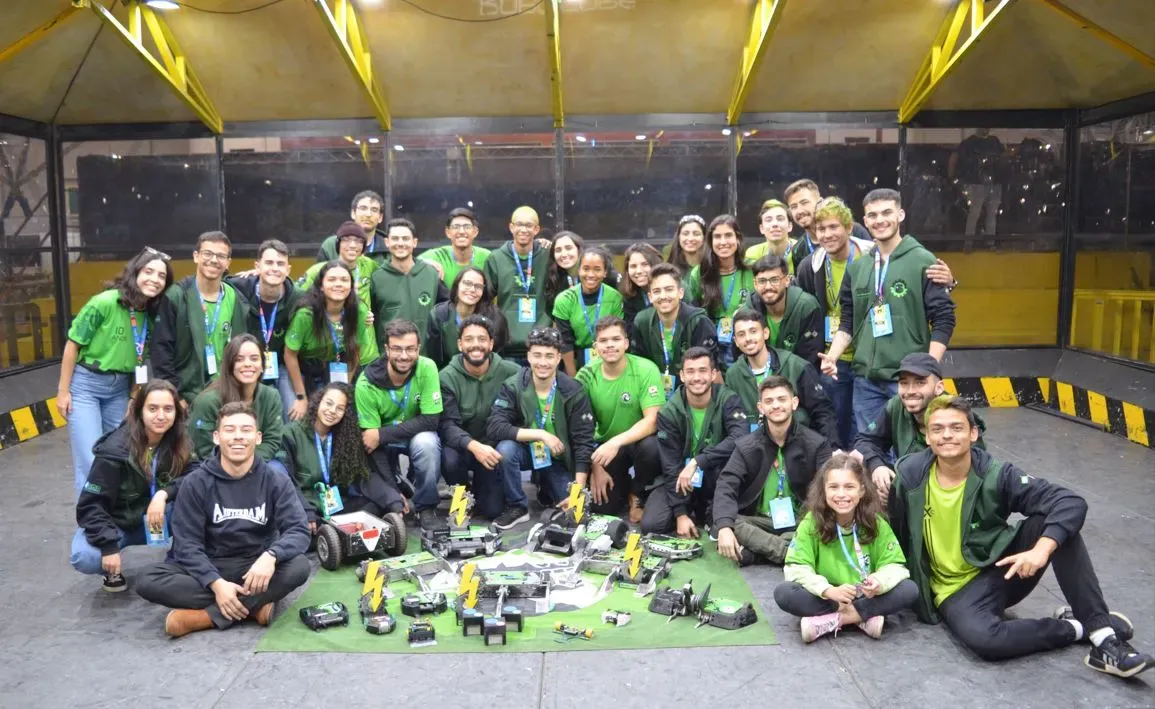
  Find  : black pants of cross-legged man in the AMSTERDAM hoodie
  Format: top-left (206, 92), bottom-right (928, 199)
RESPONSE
top-left (136, 555), bottom-right (310, 628)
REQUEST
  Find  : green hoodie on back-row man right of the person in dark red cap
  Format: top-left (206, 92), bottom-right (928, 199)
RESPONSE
top-left (368, 259), bottom-right (449, 355)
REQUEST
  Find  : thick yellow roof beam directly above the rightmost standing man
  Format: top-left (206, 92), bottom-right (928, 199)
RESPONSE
top-left (899, 0), bottom-right (1014, 124)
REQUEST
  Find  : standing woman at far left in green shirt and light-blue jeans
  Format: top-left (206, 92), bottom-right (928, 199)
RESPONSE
top-left (57, 247), bottom-right (172, 497)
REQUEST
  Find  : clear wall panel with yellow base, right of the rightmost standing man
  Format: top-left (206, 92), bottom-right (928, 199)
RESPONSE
top-left (903, 128), bottom-right (1067, 346)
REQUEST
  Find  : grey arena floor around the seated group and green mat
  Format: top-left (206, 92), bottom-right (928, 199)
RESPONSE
top-left (0, 409), bottom-right (1155, 709)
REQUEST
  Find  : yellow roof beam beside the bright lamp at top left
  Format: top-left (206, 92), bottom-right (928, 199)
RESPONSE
top-left (84, 0), bottom-right (224, 133)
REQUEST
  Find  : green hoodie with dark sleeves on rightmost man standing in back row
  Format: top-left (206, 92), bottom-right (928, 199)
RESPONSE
top-left (840, 236), bottom-right (955, 381)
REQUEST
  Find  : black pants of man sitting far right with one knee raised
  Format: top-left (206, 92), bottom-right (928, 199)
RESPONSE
top-left (938, 515), bottom-right (1111, 659)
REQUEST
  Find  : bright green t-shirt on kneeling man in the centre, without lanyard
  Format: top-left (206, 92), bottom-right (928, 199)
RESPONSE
top-left (578, 355), bottom-right (665, 442)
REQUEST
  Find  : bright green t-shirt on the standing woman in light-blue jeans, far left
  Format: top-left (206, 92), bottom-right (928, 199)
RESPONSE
top-left (68, 289), bottom-right (151, 374)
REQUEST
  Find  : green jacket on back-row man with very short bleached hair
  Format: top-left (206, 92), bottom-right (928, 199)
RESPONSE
top-left (484, 241), bottom-right (550, 357)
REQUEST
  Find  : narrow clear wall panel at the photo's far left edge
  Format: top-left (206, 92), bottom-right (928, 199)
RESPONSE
top-left (0, 133), bottom-right (61, 372)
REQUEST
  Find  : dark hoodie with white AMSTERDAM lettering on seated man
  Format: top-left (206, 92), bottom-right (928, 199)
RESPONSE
top-left (169, 455), bottom-right (310, 588)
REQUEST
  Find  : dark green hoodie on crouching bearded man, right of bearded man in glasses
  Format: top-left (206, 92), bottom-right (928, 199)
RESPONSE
top-left (439, 352), bottom-right (521, 454)
